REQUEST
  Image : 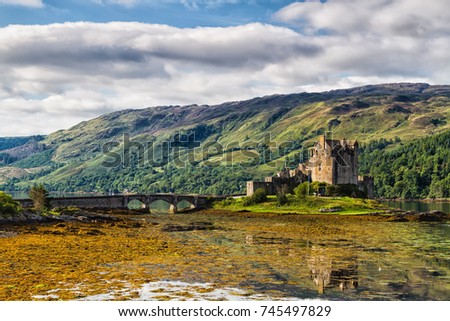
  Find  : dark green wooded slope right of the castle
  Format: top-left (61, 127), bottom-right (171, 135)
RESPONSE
top-left (360, 131), bottom-right (450, 198)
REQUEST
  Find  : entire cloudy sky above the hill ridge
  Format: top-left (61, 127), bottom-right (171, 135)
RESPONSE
top-left (0, 0), bottom-right (450, 136)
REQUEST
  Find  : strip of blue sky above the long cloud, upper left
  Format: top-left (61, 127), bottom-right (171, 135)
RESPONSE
top-left (0, 0), bottom-right (298, 27)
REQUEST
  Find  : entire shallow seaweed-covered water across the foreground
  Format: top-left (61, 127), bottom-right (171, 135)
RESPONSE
top-left (6, 211), bottom-right (450, 300)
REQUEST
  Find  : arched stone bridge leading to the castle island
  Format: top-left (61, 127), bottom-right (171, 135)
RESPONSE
top-left (17, 194), bottom-right (226, 213)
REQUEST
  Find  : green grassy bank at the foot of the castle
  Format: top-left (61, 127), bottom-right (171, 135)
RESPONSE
top-left (214, 195), bottom-right (385, 215)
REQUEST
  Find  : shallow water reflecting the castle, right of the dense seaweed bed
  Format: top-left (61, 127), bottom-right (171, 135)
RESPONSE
top-left (134, 214), bottom-right (450, 300)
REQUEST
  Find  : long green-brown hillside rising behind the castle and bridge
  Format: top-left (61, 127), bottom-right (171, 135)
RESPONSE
top-left (0, 83), bottom-right (450, 198)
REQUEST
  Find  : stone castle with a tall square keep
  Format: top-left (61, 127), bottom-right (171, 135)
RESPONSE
top-left (247, 136), bottom-right (373, 198)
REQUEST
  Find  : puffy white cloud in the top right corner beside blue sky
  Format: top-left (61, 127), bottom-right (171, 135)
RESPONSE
top-left (274, 0), bottom-right (450, 37)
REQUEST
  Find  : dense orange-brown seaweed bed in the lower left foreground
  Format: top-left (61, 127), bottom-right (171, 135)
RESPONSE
top-left (0, 222), bottom-right (192, 300)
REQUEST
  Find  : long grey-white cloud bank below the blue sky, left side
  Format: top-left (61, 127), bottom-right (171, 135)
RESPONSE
top-left (0, 22), bottom-right (321, 135)
